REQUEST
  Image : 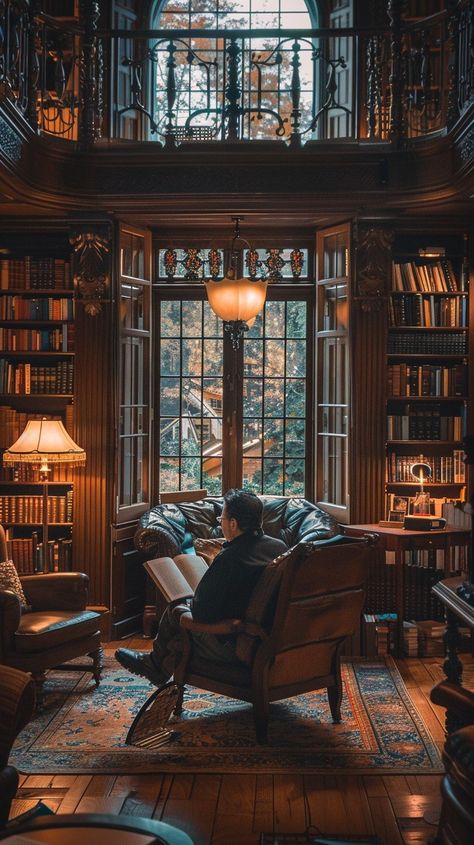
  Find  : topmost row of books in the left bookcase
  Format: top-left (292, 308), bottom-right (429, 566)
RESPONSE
top-left (0, 255), bottom-right (72, 290)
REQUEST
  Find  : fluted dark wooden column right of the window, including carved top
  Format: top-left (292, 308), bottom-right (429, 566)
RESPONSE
top-left (349, 222), bottom-right (393, 523)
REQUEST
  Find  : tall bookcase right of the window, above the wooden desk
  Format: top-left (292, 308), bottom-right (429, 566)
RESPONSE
top-left (385, 237), bottom-right (469, 528)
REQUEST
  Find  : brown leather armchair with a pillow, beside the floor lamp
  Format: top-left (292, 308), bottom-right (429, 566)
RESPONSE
top-left (0, 526), bottom-right (102, 705)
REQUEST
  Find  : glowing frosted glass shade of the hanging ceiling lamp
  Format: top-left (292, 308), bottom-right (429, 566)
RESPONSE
top-left (205, 276), bottom-right (268, 323)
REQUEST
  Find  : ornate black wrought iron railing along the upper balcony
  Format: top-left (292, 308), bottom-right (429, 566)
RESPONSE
top-left (0, 0), bottom-right (474, 147)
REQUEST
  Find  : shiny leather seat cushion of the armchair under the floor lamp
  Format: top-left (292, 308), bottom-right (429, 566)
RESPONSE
top-left (15, 610), bottom-right (100, 653)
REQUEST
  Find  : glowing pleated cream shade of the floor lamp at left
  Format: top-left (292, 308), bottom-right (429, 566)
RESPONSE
top-left (3, 419), bottom-right (86, 464)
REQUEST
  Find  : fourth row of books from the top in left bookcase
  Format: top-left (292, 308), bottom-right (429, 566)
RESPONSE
top-left (0, 358), bottom-right (74, 395)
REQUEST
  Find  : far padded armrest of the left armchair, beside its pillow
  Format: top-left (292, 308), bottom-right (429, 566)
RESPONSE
top-left (20, 572), bottom-right (89, 610)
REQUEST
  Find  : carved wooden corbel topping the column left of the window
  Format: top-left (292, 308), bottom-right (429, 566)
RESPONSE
top-left (69, 226), bottom-right (111, 317)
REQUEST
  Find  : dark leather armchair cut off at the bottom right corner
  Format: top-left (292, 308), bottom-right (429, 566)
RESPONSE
top-left (430, 681), bottom-right (474, 845)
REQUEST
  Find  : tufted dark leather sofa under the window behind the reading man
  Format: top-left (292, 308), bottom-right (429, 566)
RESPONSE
top-left (134, 496), bottom-right (343, 560)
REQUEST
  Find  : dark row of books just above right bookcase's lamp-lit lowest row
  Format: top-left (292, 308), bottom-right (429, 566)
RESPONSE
top-left (387, 405), bottom-right (465, 441)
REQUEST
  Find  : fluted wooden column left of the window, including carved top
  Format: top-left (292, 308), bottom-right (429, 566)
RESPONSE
top-left (70, 226), bottom-right (115, 607)
